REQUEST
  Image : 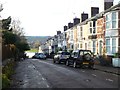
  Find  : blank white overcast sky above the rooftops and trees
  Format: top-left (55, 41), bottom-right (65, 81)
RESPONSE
top-left (0, 0), bottom-right (120, 36)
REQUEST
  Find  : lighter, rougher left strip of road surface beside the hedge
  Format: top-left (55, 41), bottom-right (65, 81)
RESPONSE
top-left (10, 60), bottom-right (49, 88)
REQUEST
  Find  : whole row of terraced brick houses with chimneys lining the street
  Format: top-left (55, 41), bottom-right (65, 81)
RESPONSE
top-left (40, 2), bottom-right (120, 56)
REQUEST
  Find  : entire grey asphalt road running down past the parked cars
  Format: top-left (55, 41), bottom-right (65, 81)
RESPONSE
top-left (11, 59), bottom-right (118, 88)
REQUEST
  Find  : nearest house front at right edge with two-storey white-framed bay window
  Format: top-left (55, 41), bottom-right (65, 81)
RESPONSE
top-left (104, 3), bottom-right (120, 56)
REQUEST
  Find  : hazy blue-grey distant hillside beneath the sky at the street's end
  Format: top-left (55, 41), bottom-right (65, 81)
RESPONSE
top-left (25, 36), bottom-right (51, 43)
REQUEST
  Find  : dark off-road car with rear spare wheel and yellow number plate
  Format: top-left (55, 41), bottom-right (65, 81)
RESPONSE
top-left (66, 50), bottom-right (94, 68)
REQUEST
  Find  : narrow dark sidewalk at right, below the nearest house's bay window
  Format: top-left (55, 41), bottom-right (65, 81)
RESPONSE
top-left (94, 64), bottom-right (120, 75)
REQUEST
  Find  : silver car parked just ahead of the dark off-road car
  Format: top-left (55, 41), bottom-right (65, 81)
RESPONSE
top-left (53, 51), bottom-right (70, 63)
